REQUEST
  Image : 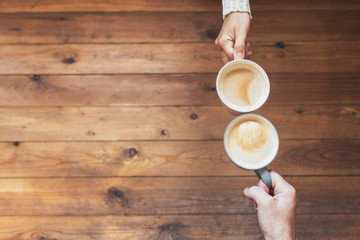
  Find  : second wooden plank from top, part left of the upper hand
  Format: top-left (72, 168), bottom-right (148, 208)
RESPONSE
top-left (0, 12), bottom-right (222, 43)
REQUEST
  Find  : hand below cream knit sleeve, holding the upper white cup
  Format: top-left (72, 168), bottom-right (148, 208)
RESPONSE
top-left (215, 12), bottom-right (252, 63)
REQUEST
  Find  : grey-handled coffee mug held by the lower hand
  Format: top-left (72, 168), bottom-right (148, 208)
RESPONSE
top-left (224, 114), bottom-right (279, 190)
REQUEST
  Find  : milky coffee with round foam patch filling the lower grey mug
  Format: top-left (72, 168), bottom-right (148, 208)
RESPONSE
top-left (227, 117), bottom-right (278, 168)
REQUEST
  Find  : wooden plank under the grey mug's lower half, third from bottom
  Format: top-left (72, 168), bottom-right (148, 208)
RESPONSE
top-left (0, 140), bottom-right (360, 178)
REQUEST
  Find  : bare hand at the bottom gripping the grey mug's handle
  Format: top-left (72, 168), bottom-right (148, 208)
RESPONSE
top-left (244, 171), bottom-right (296, 240)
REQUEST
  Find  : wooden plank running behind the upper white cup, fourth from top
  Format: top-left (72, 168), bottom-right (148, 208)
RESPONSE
top-left (0, 73), bottom-right (360, 107)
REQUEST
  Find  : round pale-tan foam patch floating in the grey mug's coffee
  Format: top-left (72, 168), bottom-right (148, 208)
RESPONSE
top-left (236, 121), bottom-right (267, 151)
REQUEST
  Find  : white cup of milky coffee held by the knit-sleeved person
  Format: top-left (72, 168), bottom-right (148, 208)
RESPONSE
top-left (216, 59), bottom-right (270, 115)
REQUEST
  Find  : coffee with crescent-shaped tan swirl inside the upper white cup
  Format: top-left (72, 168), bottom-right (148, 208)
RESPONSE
top-left (222, 66), bottom-right (264, 107)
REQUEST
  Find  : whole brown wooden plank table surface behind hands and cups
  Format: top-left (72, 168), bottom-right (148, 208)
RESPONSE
top-left (0, 0), bottom-right (360, 240)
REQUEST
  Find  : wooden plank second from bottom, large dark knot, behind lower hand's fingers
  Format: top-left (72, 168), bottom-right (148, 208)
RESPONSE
top-left (0, 176), bottom-right (360, 216)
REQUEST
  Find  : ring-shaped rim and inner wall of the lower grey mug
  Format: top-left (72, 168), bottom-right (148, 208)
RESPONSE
top-left (223, 113), bottom-right (280, 170)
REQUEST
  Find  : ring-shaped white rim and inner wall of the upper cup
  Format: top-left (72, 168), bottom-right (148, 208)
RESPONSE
top-left (216, 59), bottom-right (270, 113)
